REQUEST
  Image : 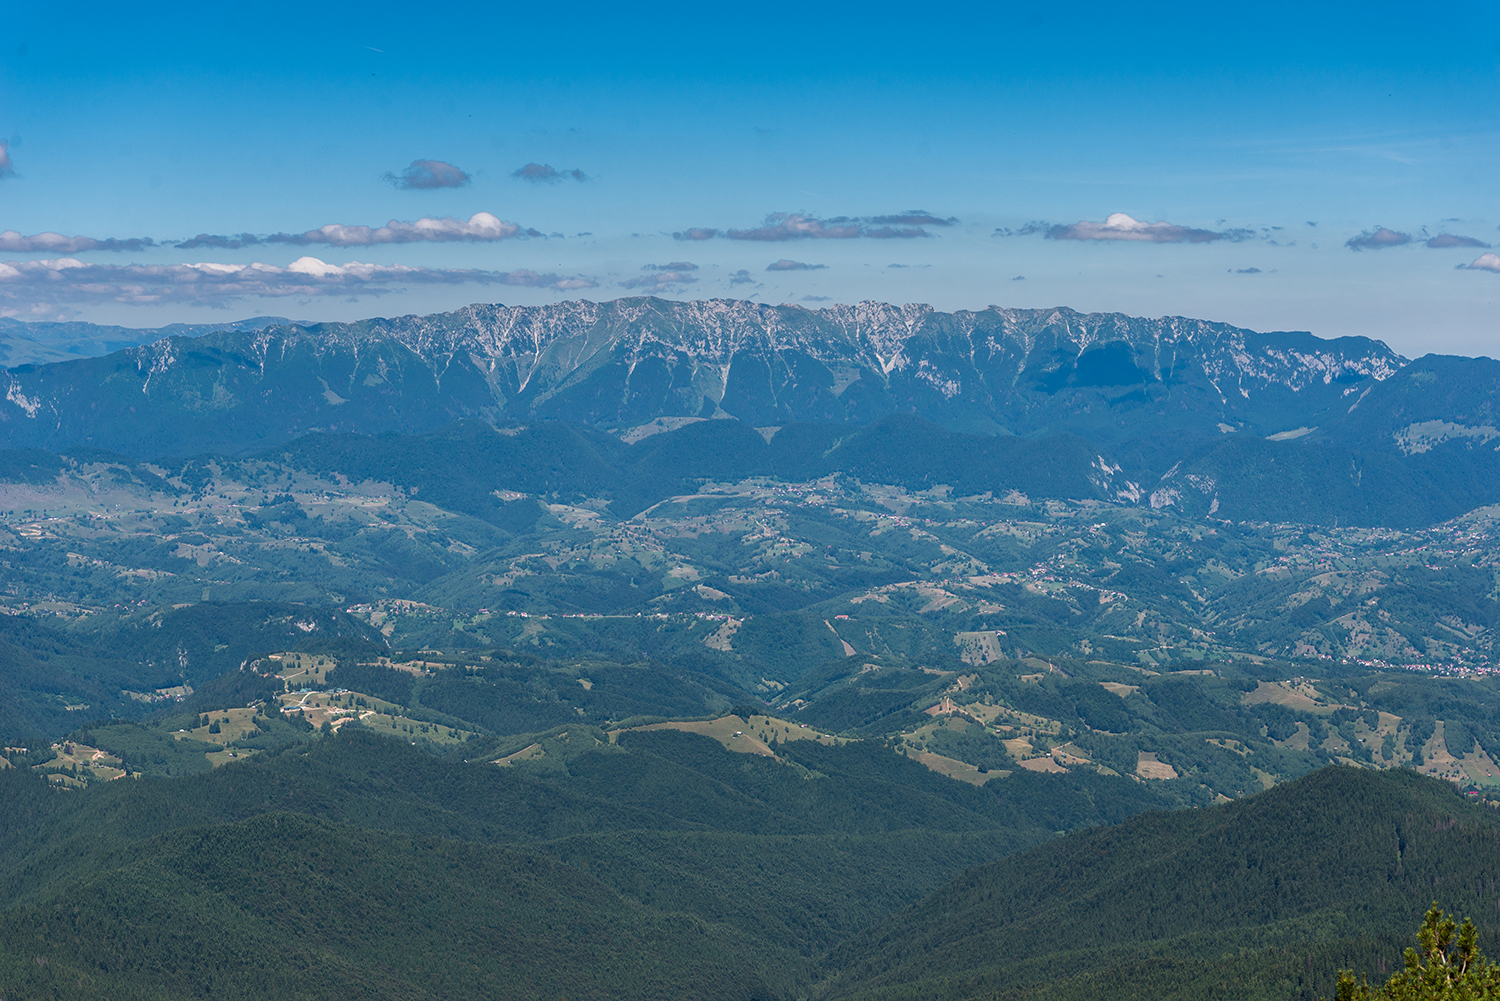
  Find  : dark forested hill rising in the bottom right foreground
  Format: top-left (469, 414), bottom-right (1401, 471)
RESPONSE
top-left (827, 767), bottom-right (1500, 1001)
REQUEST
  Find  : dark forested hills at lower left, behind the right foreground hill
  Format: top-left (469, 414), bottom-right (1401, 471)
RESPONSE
top-left (0, 725), bottom-right (1172, 1001)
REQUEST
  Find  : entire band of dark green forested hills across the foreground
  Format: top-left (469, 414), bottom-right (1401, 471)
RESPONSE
top-left (0, 726), bottom-right (1500, 1001)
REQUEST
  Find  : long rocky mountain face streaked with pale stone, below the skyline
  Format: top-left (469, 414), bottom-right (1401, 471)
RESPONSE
top-left (0, 299), bottom-right (1406, 465)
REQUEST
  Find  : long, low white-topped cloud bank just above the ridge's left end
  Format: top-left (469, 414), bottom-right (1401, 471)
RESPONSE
top-left (0, 257), bottom-right (597, 314)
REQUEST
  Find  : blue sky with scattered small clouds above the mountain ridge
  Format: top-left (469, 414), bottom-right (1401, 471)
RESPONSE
top-left (0, 3), bottom-right (1500, 356)
